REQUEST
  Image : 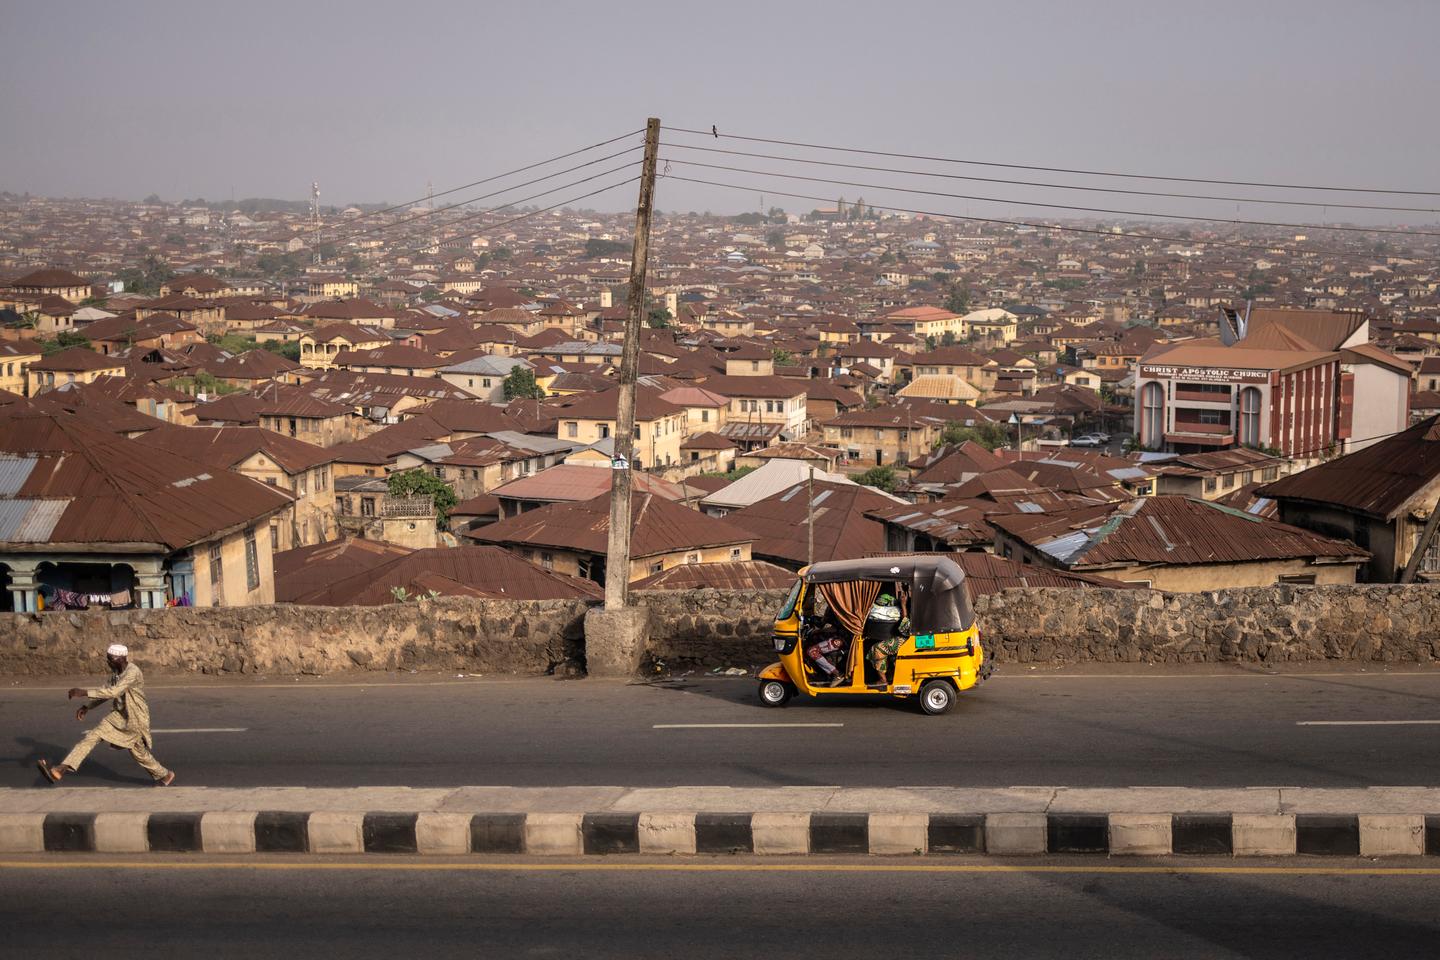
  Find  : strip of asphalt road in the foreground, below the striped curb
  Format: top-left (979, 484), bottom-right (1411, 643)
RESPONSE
top-left (0, 855), bottom-right (1440, 960)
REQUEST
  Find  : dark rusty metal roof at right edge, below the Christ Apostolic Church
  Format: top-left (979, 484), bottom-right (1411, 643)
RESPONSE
top-left (1259, 416), bottom-right (1440, 520)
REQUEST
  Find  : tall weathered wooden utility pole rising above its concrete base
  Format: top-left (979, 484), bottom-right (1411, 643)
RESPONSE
top-left (605, 117), bottom-right (660, 610)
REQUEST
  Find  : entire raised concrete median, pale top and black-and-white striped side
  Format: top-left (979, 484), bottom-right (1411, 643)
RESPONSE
top-left (0, 786), bottom-right (1440, 856)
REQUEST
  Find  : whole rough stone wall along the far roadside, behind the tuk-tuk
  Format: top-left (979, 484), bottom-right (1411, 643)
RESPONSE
top-left (8, 584), bottom-right (1440, 675)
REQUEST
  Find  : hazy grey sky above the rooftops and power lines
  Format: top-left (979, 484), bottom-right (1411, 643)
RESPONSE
top-left (0, 0), bottom-right (1440, 222)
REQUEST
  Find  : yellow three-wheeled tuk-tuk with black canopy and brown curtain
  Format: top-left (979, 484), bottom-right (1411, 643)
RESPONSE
top-left (760, 556), bottom-right (994, 714)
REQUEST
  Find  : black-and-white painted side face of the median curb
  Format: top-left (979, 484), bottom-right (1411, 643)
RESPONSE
top-left (0, 810), bottom-right (1440, 856)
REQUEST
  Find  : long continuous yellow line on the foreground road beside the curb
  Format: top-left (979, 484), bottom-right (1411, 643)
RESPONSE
top-left (0, 853), bottom-right (1440, 877)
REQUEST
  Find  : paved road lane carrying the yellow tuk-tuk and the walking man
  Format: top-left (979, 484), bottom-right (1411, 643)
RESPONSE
top-left (0, 671), bottom-right (1440, 787)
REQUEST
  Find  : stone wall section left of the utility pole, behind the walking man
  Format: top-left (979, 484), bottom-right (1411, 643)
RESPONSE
top-left (0, 599), bottom-right (585, 675)
